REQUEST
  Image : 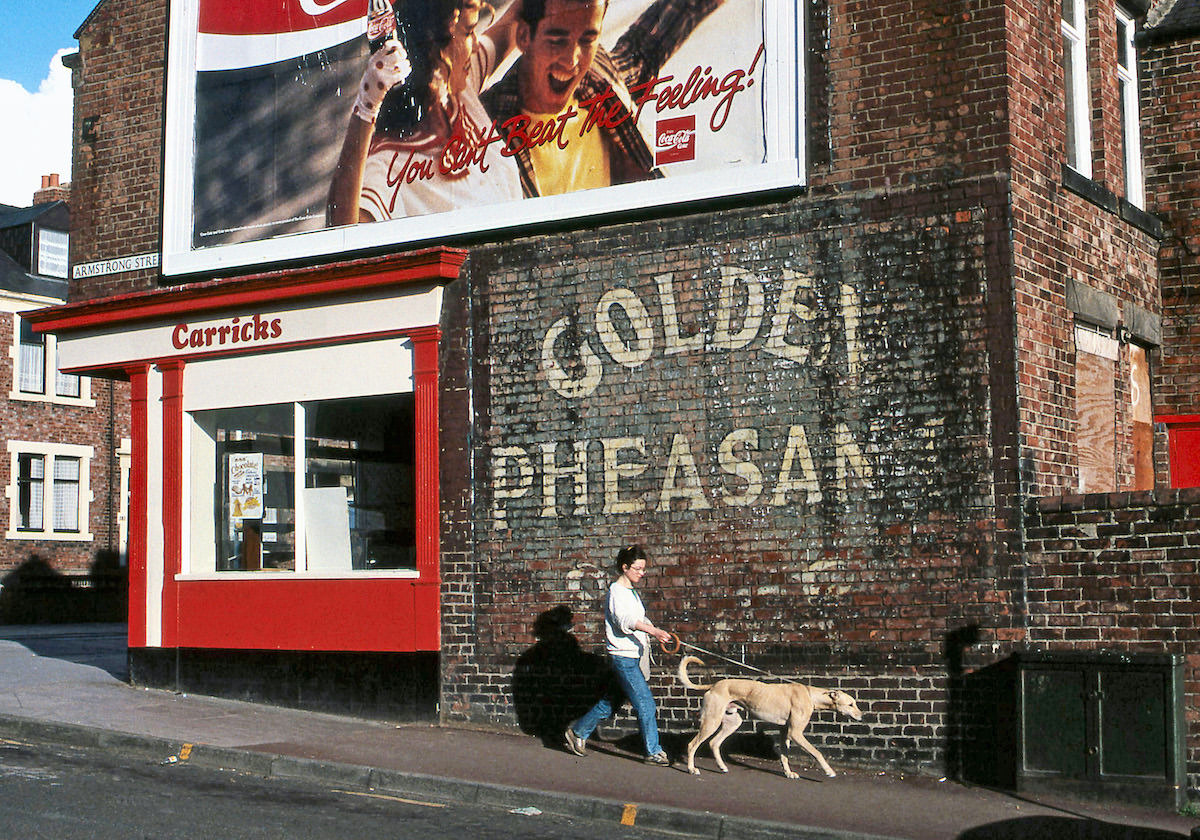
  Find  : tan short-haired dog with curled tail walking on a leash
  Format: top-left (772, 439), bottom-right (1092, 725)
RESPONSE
top-left (676, 656), bottom-right (863, 779)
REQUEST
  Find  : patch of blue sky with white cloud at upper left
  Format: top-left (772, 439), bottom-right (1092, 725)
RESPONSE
top-left (0, 0), bottom-right (100, 206)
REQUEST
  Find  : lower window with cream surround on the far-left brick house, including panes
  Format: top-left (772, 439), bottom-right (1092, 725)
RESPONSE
top-left (5, 440), bottom-right (94, 540)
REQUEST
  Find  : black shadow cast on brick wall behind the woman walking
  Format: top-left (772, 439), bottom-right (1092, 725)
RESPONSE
top-left (512, 605), bottom-right (608, 748)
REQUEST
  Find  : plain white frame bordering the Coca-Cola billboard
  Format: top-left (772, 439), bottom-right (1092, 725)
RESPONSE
top-left (162, 0), bottom-right (806, 276)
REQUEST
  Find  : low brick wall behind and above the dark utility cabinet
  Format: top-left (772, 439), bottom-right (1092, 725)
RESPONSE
top-left (1026, 490), bottom-right (1200, 790)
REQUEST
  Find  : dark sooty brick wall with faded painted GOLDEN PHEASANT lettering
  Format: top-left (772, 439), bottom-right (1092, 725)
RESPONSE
top-left (443, 190), bottom-right (1012, 767)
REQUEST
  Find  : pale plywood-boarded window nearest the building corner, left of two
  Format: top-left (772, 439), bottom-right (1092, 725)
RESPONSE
top-left (1075, 324), bottom-right (1118, 493)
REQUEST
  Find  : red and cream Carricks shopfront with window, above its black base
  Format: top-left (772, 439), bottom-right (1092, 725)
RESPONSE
top-left (29, 248), bottom-right (466, 652)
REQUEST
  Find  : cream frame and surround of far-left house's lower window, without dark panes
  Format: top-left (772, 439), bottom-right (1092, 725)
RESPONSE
top-left (5, 440), bottom-right (96, 542)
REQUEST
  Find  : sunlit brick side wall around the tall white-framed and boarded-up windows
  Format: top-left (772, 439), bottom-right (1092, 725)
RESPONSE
top-left (1009, 2), bottom-right (1159, 496)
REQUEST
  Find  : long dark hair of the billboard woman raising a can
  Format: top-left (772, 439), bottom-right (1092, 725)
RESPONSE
top-left (376, 0), bottom-right (463, 137)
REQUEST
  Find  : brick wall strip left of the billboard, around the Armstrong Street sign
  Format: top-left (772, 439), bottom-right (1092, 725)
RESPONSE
top-left (70, 0), bottom-right (167, 300)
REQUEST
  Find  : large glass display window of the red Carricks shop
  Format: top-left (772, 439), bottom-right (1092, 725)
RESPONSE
top-left (191, 392), bottom-right (416, 574)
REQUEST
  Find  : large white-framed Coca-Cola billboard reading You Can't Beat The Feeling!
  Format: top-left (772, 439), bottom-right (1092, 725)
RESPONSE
top-left (162, 0), bottom-right (803, 275)
